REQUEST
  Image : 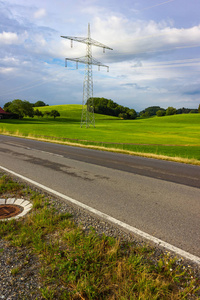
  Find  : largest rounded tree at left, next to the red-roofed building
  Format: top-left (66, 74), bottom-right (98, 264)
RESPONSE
top-left (7, 99), bottom-right (34, 119)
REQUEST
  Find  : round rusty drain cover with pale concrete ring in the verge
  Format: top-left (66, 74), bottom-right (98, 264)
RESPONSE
top-left (0, 198), bottom-right (33, 221)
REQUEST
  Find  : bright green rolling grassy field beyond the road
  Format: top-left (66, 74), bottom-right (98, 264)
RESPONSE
top-left (0, 105), bottom-right (200, 164)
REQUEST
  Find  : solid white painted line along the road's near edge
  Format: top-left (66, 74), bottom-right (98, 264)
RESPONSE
top-left (0, 166), bottom-right (200, 265)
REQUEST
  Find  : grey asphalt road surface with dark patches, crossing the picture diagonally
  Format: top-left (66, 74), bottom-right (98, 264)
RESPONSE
top-left (0, 135), bottom-right (200, 257)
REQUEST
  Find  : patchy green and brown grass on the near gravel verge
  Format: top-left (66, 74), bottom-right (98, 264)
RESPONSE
top-left (0, 175), bottom-right (199, 300)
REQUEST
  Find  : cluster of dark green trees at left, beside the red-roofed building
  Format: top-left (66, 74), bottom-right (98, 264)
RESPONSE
top-left (3, 99), bottom-right (60, 119)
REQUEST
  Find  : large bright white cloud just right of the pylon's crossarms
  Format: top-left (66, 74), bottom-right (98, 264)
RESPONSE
top-left (91, 15), bottom-right (200, 61)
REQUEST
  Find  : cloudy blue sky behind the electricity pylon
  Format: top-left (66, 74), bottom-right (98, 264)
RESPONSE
top-left (0, 0), bottom-right (200, 111)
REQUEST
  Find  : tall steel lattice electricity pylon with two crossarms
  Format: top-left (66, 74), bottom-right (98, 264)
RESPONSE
top-left (61, 24), bottom-right (113, 127)
